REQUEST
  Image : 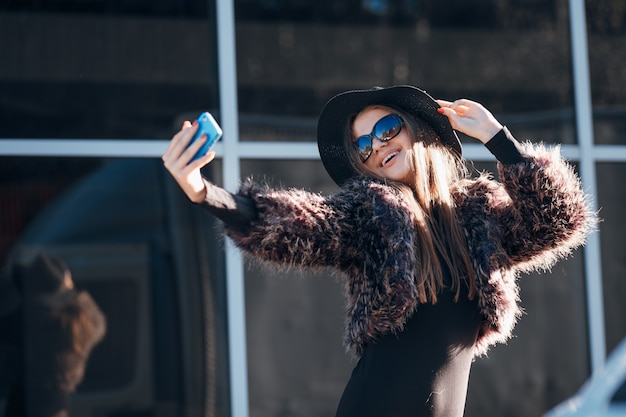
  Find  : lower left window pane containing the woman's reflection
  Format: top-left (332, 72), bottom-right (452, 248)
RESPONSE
top-left (0, 157), bottom-right (229, 416)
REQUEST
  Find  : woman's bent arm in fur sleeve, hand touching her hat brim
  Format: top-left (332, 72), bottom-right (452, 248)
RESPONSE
top-left (438, 99), bottom-right (597, 269)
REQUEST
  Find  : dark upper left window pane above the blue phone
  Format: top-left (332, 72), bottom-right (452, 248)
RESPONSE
top-left (0, 1), bottom-right (218, 139)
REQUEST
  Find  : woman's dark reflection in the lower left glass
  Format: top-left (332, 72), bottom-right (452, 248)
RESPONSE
top-left (0, 252), bottom-right (106, 417)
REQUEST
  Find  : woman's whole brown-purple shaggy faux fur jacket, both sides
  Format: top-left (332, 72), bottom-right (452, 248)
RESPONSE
top-left (212, 132), bottom-right (595, 356)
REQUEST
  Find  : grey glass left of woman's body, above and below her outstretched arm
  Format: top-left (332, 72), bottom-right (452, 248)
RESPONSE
top-left (242, 160), bottom-right (346, 416)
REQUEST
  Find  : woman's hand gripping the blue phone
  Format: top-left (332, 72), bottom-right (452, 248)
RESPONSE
top-left (161, 121), bottom-right (215, 203)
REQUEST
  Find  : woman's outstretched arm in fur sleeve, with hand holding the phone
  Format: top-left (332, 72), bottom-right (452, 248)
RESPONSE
top-left (162, 122), bottom-right (364, 267)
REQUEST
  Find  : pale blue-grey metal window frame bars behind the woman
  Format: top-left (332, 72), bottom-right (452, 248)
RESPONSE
top-left (0, 0), bottom-right (612, 417)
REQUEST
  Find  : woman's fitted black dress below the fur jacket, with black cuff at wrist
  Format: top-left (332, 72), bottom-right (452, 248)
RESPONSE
top-left (204, 182), bottom-right (481, 417)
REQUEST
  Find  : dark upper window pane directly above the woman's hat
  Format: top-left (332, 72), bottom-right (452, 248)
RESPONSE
top-left (235, 0), bottom-right (575, 143)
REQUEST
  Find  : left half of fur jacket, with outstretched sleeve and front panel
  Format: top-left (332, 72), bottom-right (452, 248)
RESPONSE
top-left (227, 178), bottom-right (417, 355)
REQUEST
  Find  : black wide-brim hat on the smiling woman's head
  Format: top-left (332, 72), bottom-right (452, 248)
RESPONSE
top-left (317, 85), bottom-right (462, 186)
